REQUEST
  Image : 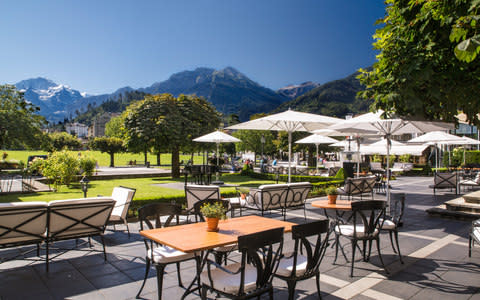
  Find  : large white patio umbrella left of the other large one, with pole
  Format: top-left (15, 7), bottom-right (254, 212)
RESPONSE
top-left (227, 109), bottom-right (342, 182)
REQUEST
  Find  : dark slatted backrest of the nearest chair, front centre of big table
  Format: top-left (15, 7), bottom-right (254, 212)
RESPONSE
top-left (238, 227), bottom-right (284, 294)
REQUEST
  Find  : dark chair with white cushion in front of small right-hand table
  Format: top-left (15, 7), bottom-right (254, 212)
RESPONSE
top-left (333, 200), bottom-right (388, 277)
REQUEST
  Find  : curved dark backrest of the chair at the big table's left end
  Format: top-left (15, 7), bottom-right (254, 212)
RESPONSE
top-left (138, 203), bottom-right (182, 230)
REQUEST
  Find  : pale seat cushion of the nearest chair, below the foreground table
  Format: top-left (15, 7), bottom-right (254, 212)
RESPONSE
top-left (200, 263), bottom-right (257, 295)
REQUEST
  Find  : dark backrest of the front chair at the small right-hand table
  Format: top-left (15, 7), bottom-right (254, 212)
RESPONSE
top-left (351, 200), bottom-right (387, 239)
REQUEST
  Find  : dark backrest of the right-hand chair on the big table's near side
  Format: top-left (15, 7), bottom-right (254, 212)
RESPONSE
top-left (292, 219), bottom-right (329, 277)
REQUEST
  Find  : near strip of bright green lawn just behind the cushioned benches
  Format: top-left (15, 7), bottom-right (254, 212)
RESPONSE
top-left (0, 174), bottom-right (282, 202)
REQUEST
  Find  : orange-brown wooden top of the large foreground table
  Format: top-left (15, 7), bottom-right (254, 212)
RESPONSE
top-left (140, 216), bottom-right (296, 253)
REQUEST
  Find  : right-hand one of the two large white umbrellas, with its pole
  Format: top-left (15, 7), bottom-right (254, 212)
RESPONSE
top-left (328, 110), bottom-right (453, 205)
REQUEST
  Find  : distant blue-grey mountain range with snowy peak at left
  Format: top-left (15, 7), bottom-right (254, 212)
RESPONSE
top-left (15, 67), bottom-right (368, 123)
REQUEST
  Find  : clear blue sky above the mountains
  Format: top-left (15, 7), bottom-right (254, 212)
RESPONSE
top-left (0, 0), bottom-right (385, 94)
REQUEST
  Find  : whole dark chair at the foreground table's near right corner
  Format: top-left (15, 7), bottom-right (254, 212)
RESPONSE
top-left (275, 219), bottom-right (329, 300)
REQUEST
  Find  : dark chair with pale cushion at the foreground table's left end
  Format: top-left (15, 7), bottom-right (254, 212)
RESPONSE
top-left (136, 203), bottom-right (200, 299)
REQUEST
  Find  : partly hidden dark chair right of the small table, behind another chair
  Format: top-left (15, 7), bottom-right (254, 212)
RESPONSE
top-left (380, 193), bottom-right (405, 264)
